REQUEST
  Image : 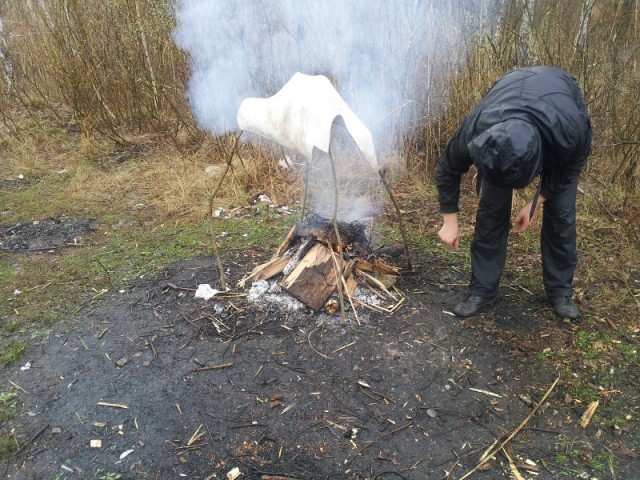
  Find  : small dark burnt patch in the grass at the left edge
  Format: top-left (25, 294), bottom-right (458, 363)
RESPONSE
top-left (0, 216), bottom-right (97, 252)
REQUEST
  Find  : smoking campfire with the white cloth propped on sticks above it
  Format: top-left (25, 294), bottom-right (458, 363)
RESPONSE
top-left (237, 73), bottom-right (411, 318)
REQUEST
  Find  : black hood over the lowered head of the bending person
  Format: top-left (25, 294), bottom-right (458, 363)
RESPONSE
top-left (467, 119), bottom-right (542, 188)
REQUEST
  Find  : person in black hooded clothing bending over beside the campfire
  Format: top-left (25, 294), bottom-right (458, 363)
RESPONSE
top-left (436, 66), bottom-right (592, 319)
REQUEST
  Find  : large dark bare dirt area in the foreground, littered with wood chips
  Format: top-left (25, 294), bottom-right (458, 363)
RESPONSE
top-left (0, 218), bottom-right (640, 480)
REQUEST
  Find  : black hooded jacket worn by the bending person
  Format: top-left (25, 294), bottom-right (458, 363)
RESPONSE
top-left (436, 66), bottom-right (591, 213)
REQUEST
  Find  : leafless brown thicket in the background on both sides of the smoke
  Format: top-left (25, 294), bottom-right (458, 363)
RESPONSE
top-left (0, 0), bottom-right (640, 227)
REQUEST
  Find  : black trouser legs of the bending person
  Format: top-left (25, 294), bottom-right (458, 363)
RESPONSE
top-left (469, 179), bottom-right (578, 297)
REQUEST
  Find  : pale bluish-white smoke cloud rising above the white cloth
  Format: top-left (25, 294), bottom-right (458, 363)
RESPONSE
top-left (174, 0), bottom-right (491, 147)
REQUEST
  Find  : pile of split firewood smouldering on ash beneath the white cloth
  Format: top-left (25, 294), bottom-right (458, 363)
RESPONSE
top-left (239, 214), bottom-right (404, 313)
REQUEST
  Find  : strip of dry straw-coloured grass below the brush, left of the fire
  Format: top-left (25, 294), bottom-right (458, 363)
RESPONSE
top-left (0, 126), bottom-right (301, 220)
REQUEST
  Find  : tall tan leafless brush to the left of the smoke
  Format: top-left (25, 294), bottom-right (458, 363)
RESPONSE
top-left (1, 0), bottom-right (190, 143)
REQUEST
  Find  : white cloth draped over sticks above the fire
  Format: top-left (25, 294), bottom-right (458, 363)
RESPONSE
top-left (237, 73), bottom-right (379, 172)
